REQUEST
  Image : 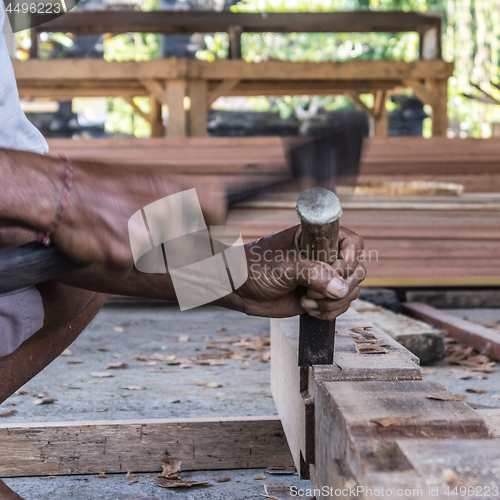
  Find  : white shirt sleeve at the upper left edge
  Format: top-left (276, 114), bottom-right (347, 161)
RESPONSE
top-left (0, 0), bottom-right (49, 154)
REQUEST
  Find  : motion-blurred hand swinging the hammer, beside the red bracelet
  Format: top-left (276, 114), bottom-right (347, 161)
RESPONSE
top-left (52, 162), bottom-right (226, 269)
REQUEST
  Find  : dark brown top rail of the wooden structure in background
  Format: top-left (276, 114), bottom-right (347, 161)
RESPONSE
top-left (27, 9), bottom-right (441, 34)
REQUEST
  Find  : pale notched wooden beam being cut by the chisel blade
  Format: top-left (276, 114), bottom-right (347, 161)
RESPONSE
top-left (271, 310), bottom-right (422, 478)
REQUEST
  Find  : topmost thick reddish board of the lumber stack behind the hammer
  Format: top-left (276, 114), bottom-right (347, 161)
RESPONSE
top-left (49, 137), bottom-right (500, 193)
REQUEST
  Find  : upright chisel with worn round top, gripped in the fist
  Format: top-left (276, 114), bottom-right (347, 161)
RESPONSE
top-left (297, 188), bottom-right (342, 366)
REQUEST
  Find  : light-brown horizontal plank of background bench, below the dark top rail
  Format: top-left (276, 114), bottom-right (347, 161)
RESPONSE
top-left (12, 58), bottom-right (453, 82)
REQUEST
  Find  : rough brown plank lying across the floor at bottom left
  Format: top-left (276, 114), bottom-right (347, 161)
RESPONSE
top-left (0, 416), bottom-right (293, 477)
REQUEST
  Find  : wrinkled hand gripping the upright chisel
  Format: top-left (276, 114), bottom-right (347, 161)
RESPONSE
top-left (229, 226), bottom-right (366, 320)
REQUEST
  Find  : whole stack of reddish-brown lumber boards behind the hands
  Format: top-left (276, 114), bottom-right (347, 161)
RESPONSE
top-left (49, 137), bottom-right (500, 287)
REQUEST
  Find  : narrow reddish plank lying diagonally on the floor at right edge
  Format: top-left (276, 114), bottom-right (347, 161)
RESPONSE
top-left (403, 302), bottom-right (500, 361)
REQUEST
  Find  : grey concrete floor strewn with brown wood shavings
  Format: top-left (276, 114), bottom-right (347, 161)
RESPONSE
top-left (0, 303), bottom-right (500, 500)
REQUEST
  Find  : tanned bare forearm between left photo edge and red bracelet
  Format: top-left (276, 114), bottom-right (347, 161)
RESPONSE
top-left (0, 148), bottom-right (61, 231)
